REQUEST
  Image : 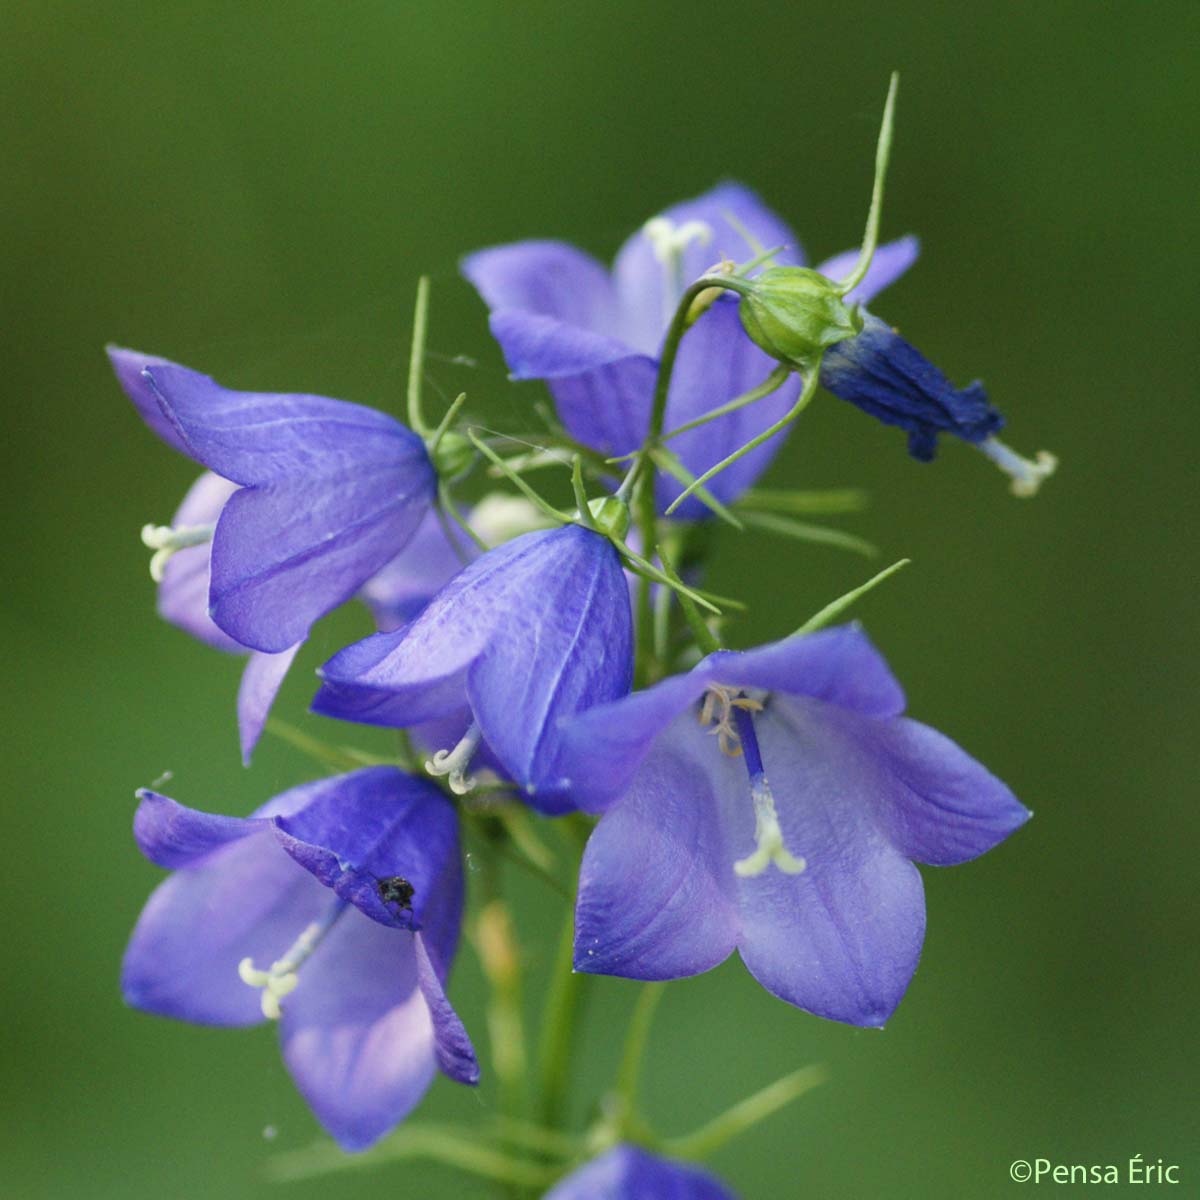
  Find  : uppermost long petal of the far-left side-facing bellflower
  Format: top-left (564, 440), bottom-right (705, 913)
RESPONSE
top-left (142, 362), bottom-right (430, 486)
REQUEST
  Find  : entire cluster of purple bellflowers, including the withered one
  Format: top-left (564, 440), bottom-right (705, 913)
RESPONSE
top-left (109, 184), bottom-right (1028, 1180)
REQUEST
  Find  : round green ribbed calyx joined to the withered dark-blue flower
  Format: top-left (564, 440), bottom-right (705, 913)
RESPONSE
top-left (738, 266), bottom-right (863, 371)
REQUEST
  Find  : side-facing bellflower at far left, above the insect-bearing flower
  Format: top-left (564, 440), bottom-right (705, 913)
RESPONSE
top-left (109, 347), bottom-right (437, 654)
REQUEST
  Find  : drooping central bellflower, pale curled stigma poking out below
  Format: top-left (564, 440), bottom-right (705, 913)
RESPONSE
top-left (312, 524), bottom-right (632, 814)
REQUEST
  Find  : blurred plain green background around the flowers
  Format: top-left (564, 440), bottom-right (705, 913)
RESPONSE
top-left (0, 0), bottom-right (1200, 1200)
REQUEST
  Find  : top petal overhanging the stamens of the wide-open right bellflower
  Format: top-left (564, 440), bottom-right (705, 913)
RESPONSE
top-left (707, 625), bottom-right (905, 716)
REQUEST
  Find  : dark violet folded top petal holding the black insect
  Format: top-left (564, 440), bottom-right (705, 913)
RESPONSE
top-left (275, 767), bottom-right (458, 929)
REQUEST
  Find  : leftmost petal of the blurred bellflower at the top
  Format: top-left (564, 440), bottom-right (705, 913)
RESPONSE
top-left (461, 241), bottom-right (617, 333)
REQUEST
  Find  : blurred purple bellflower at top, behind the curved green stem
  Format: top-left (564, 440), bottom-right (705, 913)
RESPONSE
top-left (462, 182), bottom-right (917, 518)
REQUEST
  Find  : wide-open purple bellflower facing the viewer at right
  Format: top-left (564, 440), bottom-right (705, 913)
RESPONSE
top-left (560, 625), bottom-right (1030, 1026)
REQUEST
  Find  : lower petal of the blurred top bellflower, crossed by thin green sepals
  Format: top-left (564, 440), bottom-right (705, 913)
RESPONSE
top-left (658, 300), bottom-right (800, 520)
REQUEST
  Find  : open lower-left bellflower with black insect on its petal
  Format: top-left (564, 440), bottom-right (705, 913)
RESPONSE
top-left (121, 767), bottom-right (479, 1151)
